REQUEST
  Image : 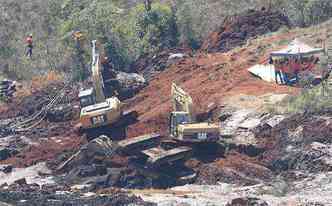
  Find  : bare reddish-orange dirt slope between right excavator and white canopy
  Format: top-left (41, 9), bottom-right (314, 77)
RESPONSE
top-left (129, 32), bottom-right (297, 136)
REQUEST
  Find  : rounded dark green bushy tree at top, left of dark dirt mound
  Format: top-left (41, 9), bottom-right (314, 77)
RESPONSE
top-left (114, 3), bottom-right (178, 60)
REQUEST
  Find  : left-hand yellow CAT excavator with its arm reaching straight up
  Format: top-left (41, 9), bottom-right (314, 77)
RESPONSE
top-left (79, 40), bottom-right (137, 136)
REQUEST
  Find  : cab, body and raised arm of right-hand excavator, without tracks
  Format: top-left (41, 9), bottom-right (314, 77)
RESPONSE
top-left (169, 83), bottom-right (220, 143)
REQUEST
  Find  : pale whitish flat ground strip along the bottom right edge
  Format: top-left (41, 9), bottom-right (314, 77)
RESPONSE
top-left (134, 173), bottom-right (332, 206)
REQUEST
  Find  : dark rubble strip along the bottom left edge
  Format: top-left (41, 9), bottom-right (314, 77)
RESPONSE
top-left (0, 185), bottom-right (156, 206)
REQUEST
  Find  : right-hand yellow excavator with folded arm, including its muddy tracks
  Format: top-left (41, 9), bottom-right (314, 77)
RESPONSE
top-left (118, 83), bottom-right (220, 166)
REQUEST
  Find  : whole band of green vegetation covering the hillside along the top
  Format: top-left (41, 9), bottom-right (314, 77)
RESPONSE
top-left (0, 0), bottom-right (332, 79)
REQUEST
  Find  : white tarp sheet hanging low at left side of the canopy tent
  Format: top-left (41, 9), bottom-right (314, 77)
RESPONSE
top-left (248, 64), bottom-right (276, 82)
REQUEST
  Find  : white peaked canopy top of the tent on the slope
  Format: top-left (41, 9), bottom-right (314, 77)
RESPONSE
top-left (271, 39), bottom-right (324, 56)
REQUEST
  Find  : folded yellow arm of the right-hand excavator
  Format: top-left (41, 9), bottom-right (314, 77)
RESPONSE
top-left (171, 83), bottom-right (194, 120)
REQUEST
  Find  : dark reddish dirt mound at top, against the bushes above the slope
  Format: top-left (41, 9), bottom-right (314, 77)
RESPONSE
top-left (202, 10), bottom-right (289, 52)
